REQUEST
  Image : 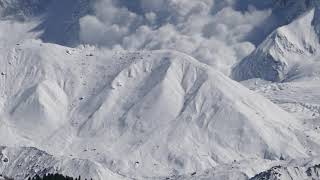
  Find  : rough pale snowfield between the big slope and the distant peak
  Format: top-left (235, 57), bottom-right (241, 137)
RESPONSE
top-left (244, 80), bottom-right (320, 121)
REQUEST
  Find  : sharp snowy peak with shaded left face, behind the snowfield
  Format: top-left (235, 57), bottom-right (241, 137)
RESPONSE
top-left (232, 8), bottom-right (320, 82)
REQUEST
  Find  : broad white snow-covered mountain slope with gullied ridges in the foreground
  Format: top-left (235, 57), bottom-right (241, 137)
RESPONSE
top-left (0, 41), bottom-right (319, 179)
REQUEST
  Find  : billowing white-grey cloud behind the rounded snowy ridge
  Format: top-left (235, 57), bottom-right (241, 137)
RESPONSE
top-left (80, 0), bottom-right (271, 74)
